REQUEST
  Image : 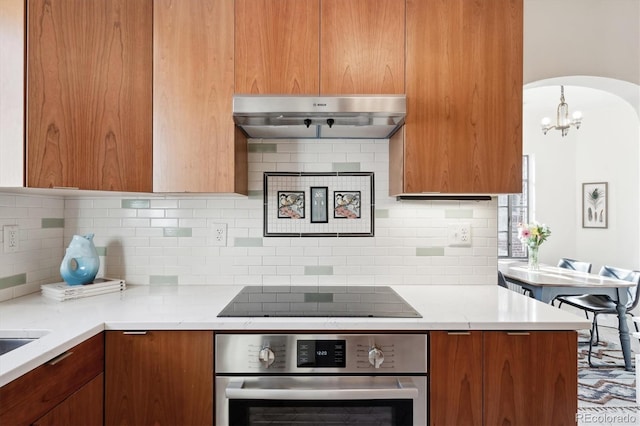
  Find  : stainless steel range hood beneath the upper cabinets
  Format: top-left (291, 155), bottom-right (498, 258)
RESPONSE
top-left (233, 95), bottom-right (407, 139)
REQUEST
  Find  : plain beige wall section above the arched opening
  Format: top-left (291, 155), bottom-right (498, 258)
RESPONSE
top-left (524, 0), bottom-right (640, 85)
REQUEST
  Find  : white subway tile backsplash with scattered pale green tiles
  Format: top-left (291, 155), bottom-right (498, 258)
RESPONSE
top-left (0, 140), bottom-right (497, 300)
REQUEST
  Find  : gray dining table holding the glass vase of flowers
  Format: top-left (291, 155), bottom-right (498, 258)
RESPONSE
top-left (498, 261), bottom-right (635, 371)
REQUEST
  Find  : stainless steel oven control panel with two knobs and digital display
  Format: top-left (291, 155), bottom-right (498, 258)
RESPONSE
top-left (215, 333), bottom-right (428, 374)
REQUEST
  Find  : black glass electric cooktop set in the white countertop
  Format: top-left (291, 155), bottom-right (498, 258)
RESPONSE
top-left (218, 286), bottom-right (422, 318)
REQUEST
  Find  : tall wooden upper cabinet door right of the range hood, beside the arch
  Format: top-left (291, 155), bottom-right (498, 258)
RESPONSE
top-left (402, 0), bottom-right (523, 193)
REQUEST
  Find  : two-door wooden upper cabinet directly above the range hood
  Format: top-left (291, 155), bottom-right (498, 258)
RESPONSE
top-left (235, 0), bottom-right (405, 95)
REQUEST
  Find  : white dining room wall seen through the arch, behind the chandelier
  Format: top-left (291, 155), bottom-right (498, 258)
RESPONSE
top-left (523, 85), bottom-right (640, 272)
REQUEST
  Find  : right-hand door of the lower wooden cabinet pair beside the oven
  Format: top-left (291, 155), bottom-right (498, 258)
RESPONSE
top-left (483, 331), bottom-right (578, 425)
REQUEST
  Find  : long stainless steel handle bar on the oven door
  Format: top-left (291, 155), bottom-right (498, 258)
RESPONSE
top-left (225, 377), bottom-right (419, 400)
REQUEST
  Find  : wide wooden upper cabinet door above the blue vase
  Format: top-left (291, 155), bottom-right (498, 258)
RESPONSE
top-left (26, 0), bottom-right (153, 191)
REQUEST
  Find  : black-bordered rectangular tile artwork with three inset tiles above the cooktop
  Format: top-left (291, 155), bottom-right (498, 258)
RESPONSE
top-left (264, 172), bottom-right (375, 237)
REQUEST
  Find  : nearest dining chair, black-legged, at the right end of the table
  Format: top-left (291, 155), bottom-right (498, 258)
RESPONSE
top-left (557, 265), bottom-right (640, 367)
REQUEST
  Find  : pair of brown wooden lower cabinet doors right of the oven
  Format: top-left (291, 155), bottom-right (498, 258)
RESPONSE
top-left (429, 331), bottom-right (578, 425)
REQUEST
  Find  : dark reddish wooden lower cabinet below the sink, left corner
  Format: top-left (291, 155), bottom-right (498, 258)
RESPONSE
top-left (0, 333), bottom-right (104, 426)
